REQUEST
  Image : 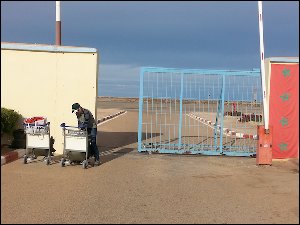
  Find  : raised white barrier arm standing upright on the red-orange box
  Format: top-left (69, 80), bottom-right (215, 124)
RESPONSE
top-left (258, 1), bottom-right (269, 133)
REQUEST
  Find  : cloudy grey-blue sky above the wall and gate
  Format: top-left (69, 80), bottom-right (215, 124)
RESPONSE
top-left (1, 1), bottom-right (299, 95)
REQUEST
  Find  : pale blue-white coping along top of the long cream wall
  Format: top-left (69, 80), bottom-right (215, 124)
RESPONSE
top-left (1, 42), bottom-right (97, 53)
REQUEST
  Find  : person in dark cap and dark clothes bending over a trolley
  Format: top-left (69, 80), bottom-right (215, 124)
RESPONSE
top-left (72, 103), bottom-right (100, 165)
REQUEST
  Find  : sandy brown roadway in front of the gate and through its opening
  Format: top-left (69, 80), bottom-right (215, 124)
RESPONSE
top-left (1, 97), bottom-right (299, 224)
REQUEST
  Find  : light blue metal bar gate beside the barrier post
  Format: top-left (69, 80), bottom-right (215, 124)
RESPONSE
top-left (138, 67), bottom-right (263, 156)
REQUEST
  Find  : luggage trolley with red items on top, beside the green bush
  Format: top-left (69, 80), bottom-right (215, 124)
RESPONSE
top-left (23, 117), bottom-right (51, 165)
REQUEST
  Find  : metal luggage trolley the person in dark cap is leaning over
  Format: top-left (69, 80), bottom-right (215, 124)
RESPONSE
top-left (60, 123), bottom-right (95, 169)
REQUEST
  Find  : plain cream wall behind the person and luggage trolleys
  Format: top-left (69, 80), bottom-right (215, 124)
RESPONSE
top-left (1, 44), bottom-right (98, 154)
